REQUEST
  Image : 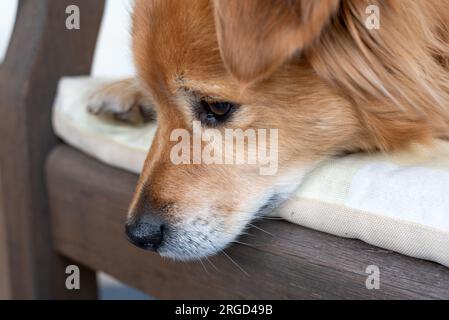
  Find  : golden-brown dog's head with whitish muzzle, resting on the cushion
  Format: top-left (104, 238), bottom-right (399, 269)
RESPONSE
top-left (127, 0), bottom-right (448, 259)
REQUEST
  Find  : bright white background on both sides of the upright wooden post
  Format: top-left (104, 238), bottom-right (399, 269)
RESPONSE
top-left (0, 0), bottom-right (134, 77)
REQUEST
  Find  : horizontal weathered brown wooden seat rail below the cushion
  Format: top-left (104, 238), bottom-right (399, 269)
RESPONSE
top-left (47, 146), bottom-right (449, 299)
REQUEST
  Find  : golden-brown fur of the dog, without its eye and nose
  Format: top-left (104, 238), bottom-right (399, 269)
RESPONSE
top-left (90, 0), bottom-right (449, 259)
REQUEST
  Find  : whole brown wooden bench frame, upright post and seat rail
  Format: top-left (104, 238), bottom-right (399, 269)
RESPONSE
top-left (0, 0), bottom-right (449, 299)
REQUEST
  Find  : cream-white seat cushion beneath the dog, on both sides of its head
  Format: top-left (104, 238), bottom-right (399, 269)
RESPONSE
top-left (53, 77), bottom-right (449, 267)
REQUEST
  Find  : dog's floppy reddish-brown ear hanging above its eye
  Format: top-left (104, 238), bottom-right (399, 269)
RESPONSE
top-left (214, 0), bottom-right (339, 83)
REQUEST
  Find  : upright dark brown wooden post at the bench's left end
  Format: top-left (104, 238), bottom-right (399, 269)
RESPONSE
top-left (0, 0), bottom-right (104, 298)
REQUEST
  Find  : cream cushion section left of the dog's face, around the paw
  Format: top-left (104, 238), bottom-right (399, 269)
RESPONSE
top-left (53, 77), bottom-right (156, 173)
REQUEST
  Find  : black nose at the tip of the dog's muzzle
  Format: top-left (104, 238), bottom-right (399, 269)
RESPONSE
top-left (126, 214), bottom-right (165, 251)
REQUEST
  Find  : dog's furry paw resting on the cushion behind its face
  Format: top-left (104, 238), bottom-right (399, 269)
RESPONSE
top-left (88, 79), bottom-right (156, 125)
